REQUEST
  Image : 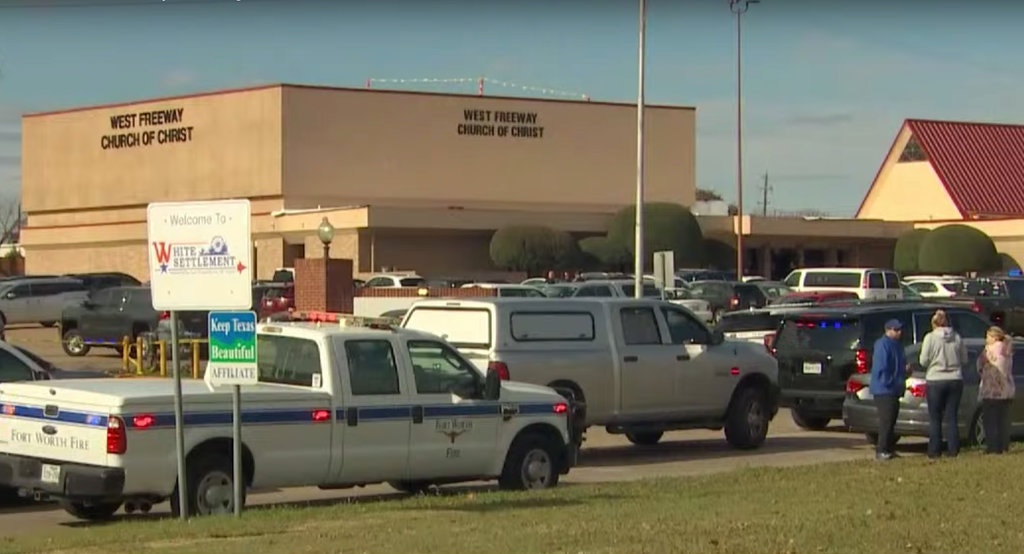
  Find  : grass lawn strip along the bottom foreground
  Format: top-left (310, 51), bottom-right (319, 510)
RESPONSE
top-left (0, 451), bottom-right (1024, 554)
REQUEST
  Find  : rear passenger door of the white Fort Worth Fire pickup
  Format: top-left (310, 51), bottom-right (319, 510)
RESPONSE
top-left (332, 336), bottom-right (412, 483)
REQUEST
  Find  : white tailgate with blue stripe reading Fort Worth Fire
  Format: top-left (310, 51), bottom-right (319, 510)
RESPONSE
top-left (0, 383), bottom-right (118, 466)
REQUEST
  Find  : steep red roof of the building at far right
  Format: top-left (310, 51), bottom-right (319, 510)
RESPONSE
top-left (906, 119), bottom-right (1024, 219)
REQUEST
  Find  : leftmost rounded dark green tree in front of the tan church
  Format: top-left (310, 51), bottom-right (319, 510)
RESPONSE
top-left (490, 225), bottom-right (579, 275)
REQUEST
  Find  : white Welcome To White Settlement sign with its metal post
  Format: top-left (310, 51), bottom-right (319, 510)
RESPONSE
top-left (146, 200), bottom-right (252, 519)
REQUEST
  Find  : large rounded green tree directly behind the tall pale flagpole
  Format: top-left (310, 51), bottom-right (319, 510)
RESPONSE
top-left (608, 202), bottom-right (703, 267)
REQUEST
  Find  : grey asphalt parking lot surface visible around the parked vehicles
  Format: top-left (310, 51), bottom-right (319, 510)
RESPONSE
top-left (0, 327), bottom-right (921, 536)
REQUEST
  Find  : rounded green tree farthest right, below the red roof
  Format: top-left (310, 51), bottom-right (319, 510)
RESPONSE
top-left (918, 223), bottom-right (1002, 273)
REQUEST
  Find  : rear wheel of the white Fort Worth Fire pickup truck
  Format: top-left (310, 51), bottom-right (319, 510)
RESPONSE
top-left (171, 454), bottom-right (246, 516)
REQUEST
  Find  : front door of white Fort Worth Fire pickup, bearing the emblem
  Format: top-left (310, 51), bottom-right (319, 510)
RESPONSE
top-left (402, 340), bottom-right (504, 480)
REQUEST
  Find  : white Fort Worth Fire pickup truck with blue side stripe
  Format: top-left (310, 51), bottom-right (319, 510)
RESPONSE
top-left (0, 314), bottom-right (577, 519)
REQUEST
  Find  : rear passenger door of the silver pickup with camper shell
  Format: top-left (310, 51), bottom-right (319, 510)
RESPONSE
top-left (612, 304), bottom-right (688, 421)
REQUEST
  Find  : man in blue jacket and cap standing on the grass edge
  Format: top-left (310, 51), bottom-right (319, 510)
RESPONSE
top-left (870, 319), bottom-right (906, 460)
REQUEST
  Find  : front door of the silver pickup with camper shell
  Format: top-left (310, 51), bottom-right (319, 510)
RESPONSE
top-left (662, 307), bottom-right (720, 417)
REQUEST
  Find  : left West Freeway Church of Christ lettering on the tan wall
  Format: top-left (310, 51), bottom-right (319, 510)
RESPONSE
top-left (99, 108), bottom-right (193, 151)
